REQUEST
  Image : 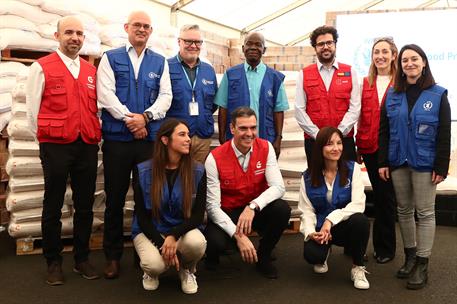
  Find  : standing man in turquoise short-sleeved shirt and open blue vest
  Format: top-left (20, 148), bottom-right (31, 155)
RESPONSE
top-left (214, 32), bottom-right (289, 157)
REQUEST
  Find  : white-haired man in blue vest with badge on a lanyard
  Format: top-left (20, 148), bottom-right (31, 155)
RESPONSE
top-left (167, 24), bottom-right (217, 163)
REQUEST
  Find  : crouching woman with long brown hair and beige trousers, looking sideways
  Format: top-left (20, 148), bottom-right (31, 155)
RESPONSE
top-left (132, 119), bottom-right (206, 294)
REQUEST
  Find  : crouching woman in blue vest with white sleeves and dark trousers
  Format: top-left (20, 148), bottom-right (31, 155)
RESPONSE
top-left (298, 127), bottom-right (370, 289)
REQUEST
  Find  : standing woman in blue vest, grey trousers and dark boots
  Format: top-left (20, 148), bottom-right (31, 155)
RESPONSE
top-left (378, 44), bottom-right (451, 289)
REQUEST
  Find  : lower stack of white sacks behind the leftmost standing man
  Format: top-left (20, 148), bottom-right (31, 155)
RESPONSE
top-left (6, 66), bottom-right (105, 238)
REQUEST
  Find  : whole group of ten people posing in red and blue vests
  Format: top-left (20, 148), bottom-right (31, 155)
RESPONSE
top-left (27, 11), bottom-right (450, 294)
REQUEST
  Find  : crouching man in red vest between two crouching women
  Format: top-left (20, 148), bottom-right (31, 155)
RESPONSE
top-left (205, 107), bottom-right (290, 279)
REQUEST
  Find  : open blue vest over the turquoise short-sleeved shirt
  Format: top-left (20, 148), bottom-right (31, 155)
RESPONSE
top-left (225, 64), bottom-right (285, 143)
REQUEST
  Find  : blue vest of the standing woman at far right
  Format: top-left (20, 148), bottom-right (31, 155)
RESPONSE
top-left (386, 85), bottom-right (446, 172)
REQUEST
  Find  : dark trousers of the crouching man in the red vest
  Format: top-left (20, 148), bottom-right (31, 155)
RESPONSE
top-left (204, 199), bottom-right (290, 262)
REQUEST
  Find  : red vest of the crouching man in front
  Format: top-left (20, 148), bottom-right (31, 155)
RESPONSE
top-left (211, 138), bottom-right (268, 211)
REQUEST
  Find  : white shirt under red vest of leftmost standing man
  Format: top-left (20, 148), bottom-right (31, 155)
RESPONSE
top-left (25, 49), bottom-right (81, 134)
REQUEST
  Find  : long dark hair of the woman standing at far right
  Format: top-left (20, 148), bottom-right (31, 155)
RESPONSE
top-left (394, 44), bottom-right (436, 93)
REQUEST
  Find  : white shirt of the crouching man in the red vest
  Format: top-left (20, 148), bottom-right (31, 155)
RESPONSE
top-left (205, 140), bottom-right (286, 237)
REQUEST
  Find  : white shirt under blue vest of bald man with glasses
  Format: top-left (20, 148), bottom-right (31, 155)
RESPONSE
top-left (97, 43), bottom-right (173, 120)
